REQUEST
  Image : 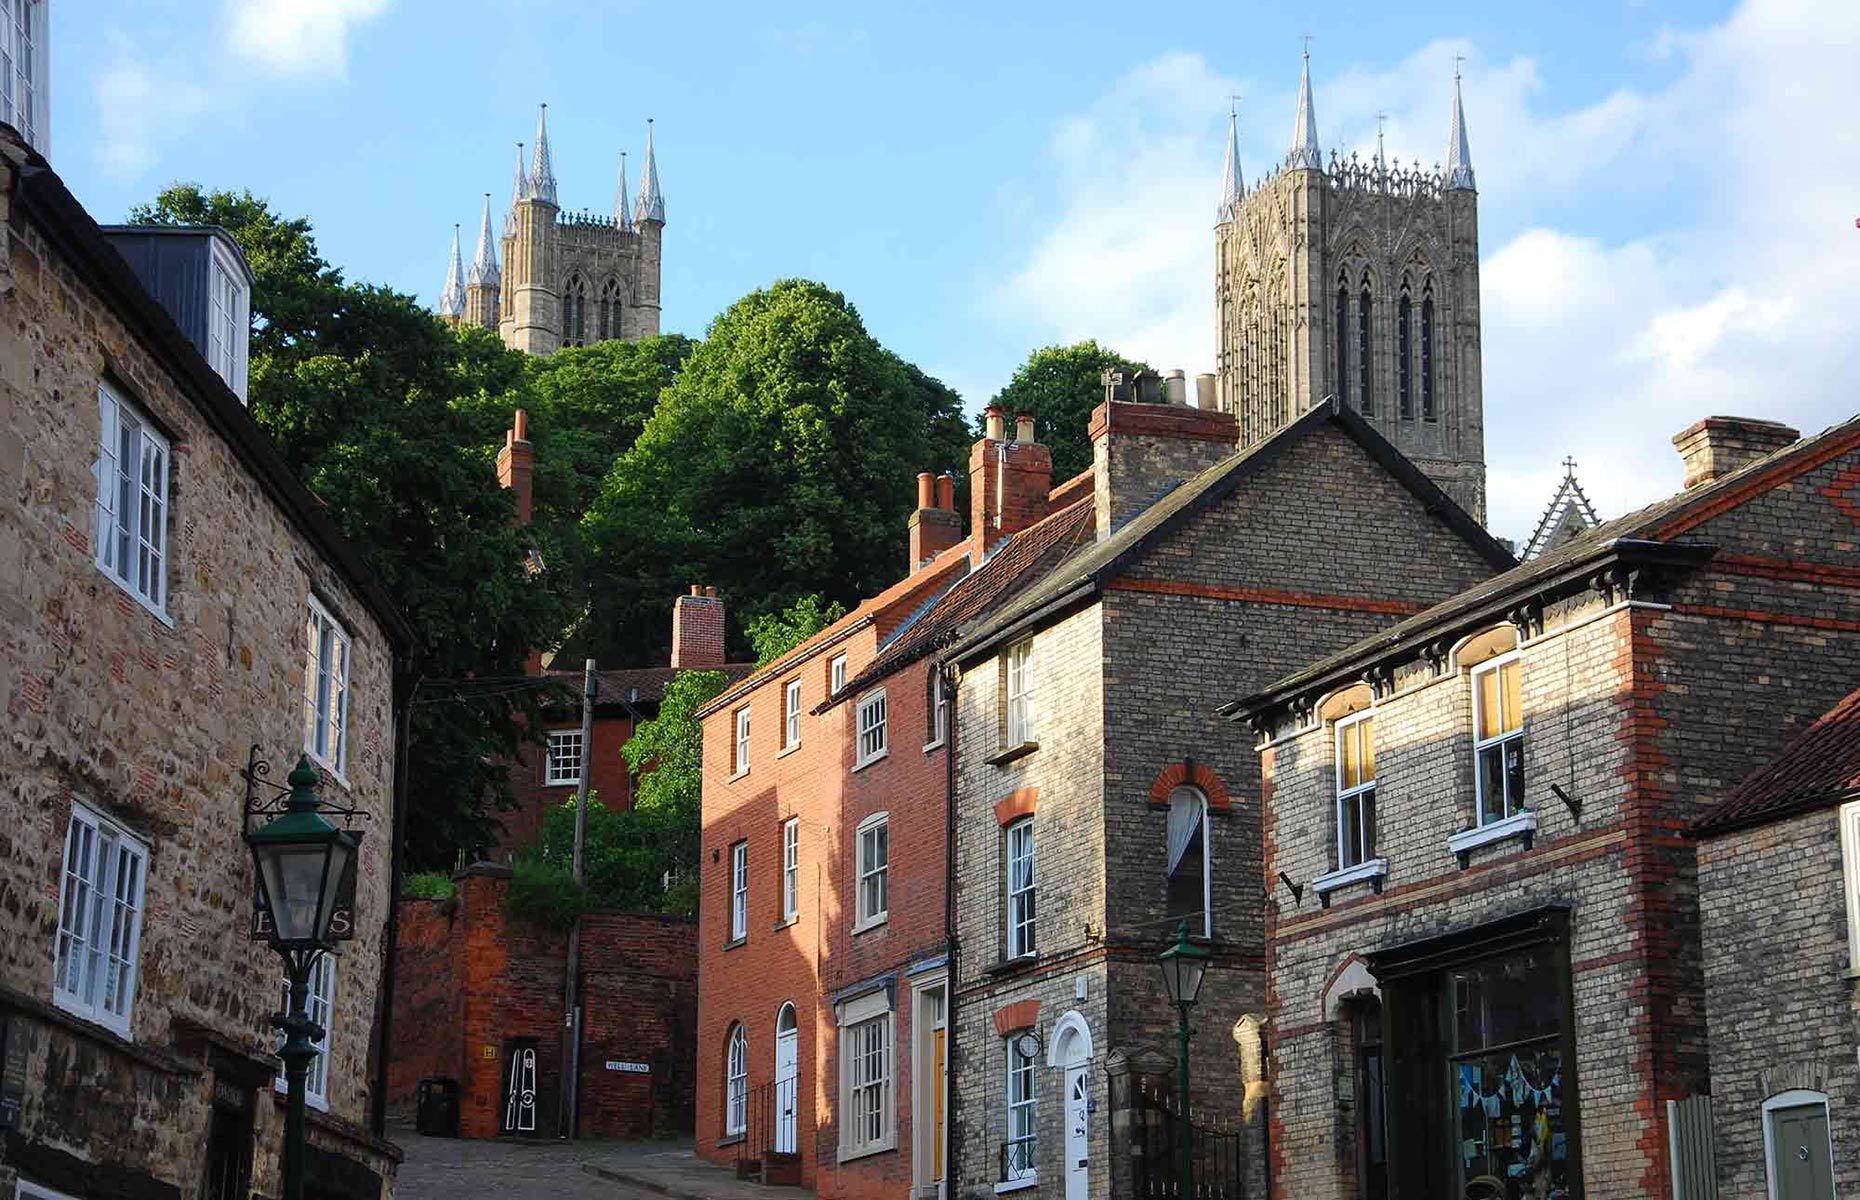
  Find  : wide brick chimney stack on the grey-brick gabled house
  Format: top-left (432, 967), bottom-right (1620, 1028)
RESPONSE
top-left (1092, 362), bottom-right (1239, 540)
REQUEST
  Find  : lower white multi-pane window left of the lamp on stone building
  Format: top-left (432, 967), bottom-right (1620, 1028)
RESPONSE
top-left (52, 802), bottom-right (149, 1040)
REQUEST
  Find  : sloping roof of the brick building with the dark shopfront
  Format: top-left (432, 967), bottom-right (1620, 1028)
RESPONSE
top-left (1222, 417), bottom-right (1860, 714)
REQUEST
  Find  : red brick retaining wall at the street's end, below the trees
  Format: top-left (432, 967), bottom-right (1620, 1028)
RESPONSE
top-left (389, 865), bottom-right (698, 1139)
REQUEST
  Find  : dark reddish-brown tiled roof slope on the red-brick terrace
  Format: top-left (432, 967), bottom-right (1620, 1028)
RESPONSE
top-left (817, 495), bottom-right (1094, 711)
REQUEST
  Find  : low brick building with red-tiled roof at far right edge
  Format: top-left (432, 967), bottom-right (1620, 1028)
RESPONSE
top-left (1693, 692), bottom-right (1860, 1200)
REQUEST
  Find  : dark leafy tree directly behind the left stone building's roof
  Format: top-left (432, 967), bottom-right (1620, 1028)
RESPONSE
top-left (134, 184), bottom-right (573, 867)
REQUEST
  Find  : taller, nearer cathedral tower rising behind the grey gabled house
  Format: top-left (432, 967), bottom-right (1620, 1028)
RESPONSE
top-left (1215, 56), bottom-right (1486, 519)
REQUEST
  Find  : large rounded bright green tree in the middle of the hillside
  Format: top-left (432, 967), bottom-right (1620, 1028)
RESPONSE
top-left (582, 279), bottom-right (969, 660)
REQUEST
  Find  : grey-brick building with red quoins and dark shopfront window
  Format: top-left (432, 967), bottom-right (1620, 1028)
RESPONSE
top-left (1228, 419), bottom-right (1860, 1200)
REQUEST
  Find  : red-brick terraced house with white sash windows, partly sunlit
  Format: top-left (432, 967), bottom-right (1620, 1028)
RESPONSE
top-left (698, 411), bottom-right (1090, 1196)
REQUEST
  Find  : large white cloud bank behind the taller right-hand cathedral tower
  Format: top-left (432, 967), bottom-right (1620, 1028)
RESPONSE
top-left (997, 0), bottom-right (1860, 538)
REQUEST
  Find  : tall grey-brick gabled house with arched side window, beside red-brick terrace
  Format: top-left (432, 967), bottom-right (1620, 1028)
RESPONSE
top-left (939, 376), bottom-right (1512, 1198)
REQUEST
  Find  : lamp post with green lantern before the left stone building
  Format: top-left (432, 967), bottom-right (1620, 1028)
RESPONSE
top-left (246, 757), bottom-right (355, 1200)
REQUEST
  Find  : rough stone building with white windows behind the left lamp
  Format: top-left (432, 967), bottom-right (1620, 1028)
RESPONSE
top-left (0, 127), bottom-right (411, 1200)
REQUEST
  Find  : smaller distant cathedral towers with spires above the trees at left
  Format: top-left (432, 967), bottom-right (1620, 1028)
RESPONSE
top-left (439, 104), bottom-right (666, 353)
